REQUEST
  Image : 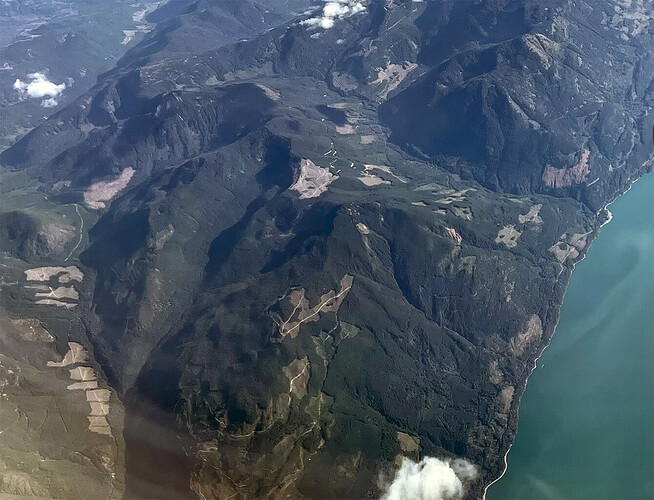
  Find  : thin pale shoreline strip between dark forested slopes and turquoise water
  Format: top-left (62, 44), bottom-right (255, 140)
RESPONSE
top-left (481, 169), bottom-right (652, 500)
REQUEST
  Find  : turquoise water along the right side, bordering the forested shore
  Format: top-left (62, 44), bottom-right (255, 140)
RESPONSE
top-left (487, 174), bottom-right (654, 500)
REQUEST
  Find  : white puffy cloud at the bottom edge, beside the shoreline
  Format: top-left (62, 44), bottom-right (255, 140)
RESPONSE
top-left (381, 457), bottom-right (478, 500)
